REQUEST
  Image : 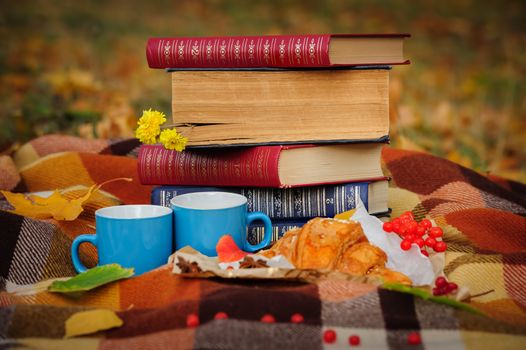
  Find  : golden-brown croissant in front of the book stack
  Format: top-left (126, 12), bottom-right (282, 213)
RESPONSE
top-left (260, 218), bottom-right (412, 285)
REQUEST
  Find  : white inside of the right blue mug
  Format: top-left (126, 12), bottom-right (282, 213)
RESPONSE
top-left (171, 192), bottom-right (247, 210)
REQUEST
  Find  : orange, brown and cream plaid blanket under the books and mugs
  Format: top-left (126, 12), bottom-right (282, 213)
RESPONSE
top-left (0, 135), bottom-right (526, 349)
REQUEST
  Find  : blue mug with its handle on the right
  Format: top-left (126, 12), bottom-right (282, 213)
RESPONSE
top-left (171, 192), bottom-right (272, 256)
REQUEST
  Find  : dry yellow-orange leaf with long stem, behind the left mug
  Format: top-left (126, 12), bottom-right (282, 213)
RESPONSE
top-left (0, 178), bottom-right (132, 221)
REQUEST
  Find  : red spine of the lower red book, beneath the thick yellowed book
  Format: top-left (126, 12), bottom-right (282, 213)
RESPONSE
top-left (137, 145), bottom-right (282, 187)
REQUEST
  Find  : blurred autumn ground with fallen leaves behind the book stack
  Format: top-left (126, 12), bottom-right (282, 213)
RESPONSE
top-left (0, 0), bottom-right (526, 182)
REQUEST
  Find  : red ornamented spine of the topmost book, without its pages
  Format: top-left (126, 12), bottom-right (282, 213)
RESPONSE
top-left (146, 34), bottom-right (331, 68)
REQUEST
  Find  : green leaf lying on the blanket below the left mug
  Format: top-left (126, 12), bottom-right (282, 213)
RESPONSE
top-left (48, 264), bottom-right (134, 293)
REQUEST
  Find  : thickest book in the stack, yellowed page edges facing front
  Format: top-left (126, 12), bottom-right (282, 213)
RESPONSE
top-left (167, 67), bottom-right (389, 146)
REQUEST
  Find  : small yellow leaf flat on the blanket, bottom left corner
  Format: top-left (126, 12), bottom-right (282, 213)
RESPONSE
top-left (64, 309), bottom-right (123, 338)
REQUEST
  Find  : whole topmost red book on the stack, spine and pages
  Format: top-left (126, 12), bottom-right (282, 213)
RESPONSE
top-left (146, 34), bottom-right (410, 68)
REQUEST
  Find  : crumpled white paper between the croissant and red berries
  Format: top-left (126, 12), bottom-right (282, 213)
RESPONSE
top-left (350, 200), bottom-right (438, 286)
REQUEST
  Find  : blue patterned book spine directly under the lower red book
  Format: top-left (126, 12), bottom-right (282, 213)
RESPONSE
top-left (151, 182), bottom-right (369, 219)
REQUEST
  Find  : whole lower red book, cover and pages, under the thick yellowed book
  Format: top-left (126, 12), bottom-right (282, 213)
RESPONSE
top-left (137, 143), bottom-right (385, 188)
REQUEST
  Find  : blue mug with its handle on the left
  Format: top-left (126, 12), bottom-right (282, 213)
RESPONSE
top-left (71, 204), bottom-right (173, 275)
